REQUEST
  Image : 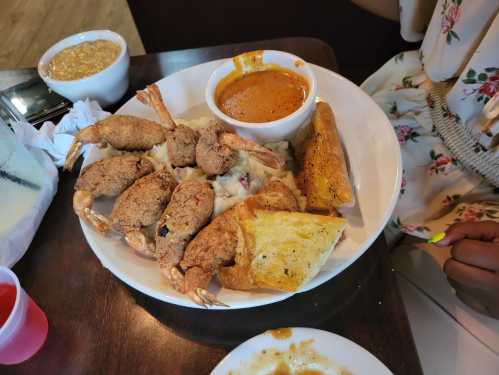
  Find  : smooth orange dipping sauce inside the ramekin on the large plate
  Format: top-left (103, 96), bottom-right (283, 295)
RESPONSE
top-left (216, 69), bottom-right (309, 123)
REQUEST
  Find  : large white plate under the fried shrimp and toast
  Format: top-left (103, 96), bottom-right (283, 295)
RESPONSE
top-left (80, 60), bottom-right (402, 309)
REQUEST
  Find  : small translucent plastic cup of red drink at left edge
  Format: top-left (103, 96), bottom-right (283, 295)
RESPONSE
top-left (0, 267), bottom-right (48, 365)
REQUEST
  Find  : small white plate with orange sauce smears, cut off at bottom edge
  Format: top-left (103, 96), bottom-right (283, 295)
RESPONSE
top-left (211, 328), bottom-right (368, 375)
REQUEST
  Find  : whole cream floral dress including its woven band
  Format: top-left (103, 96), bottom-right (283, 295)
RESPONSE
top-left (362, 0), bottom-right (499, 242)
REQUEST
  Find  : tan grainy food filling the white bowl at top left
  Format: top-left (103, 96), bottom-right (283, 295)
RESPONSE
top-left (47, 39), bottom-right (121, 81)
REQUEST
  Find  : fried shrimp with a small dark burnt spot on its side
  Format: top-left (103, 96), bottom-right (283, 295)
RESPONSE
top-left (156, 180), bottom-right (215, 289)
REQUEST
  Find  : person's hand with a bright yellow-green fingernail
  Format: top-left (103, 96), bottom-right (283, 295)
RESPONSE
top-left (436, 221), bottom-right (499, 319)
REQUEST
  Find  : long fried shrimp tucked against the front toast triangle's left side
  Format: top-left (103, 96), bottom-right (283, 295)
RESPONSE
top-left (172, 180), bottom-right (299, 306)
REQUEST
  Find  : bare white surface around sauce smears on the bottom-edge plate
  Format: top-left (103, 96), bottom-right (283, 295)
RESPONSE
top-left (211, 328), bottom-right (392, 375)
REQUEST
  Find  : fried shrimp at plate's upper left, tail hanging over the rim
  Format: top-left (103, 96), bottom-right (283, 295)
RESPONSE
top-left (64, 115), bottom-right (166, 170)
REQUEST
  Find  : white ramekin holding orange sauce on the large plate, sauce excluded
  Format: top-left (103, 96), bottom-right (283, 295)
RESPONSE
top-left (205, 50), bottom-right (317, 142)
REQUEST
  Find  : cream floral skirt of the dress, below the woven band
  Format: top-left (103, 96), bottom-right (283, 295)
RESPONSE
top-left (362, 51), bottom-right (499, 242)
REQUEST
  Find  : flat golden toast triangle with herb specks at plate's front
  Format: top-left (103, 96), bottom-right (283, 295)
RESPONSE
top-left (240, 210), bottom-right (347, 291)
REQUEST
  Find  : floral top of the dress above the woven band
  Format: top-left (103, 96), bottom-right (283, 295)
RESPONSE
top-left (399, 0), bottom-right (499, 151)
